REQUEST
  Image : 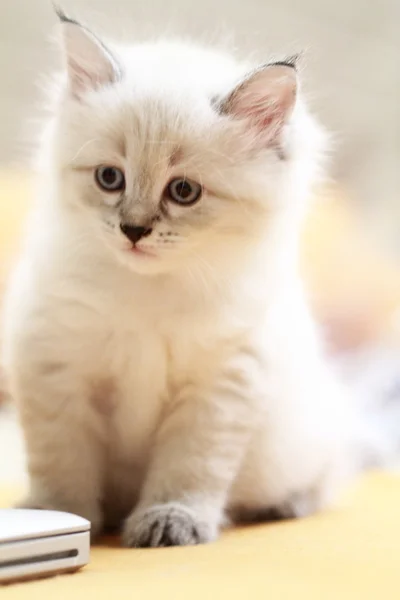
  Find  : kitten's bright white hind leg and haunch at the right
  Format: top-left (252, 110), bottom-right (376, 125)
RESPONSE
top-left (229, 359), bottom-right (356, 522)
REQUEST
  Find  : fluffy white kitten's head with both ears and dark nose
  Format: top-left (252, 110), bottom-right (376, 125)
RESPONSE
top-left (55, 15), bottom-right (322, 273)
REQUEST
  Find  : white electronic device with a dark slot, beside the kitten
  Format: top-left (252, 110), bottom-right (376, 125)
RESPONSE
top-left (0, 508), bottom-right (90, 584)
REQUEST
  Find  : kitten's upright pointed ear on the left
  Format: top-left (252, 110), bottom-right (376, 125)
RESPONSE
top-left (57, 9), bottom-right (121, 98)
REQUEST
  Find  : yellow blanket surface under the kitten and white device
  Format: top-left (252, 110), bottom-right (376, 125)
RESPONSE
top-left (0, 474), bottom-right (400, 600)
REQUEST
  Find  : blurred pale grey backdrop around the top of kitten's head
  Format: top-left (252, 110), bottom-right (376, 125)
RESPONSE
top-left (0, 0), bottom-right (400, 229)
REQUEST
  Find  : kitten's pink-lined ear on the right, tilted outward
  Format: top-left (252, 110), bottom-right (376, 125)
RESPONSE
top-left (220, 58), bottom-right (297, 145)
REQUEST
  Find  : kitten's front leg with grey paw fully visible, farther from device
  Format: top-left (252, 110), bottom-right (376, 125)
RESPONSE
top-left (123, 358), bottom-right (260, 547)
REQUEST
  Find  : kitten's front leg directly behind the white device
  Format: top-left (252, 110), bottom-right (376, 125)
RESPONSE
top-left (13, 360), bottom-right (102, 536)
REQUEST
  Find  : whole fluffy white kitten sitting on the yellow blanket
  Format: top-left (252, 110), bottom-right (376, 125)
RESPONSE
top-left (1, 17), bottom-right (390, 546)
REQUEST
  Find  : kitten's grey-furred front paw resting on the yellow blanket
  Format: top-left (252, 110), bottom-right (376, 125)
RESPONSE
top-left (123, 502), bottom-right (217, 548)
